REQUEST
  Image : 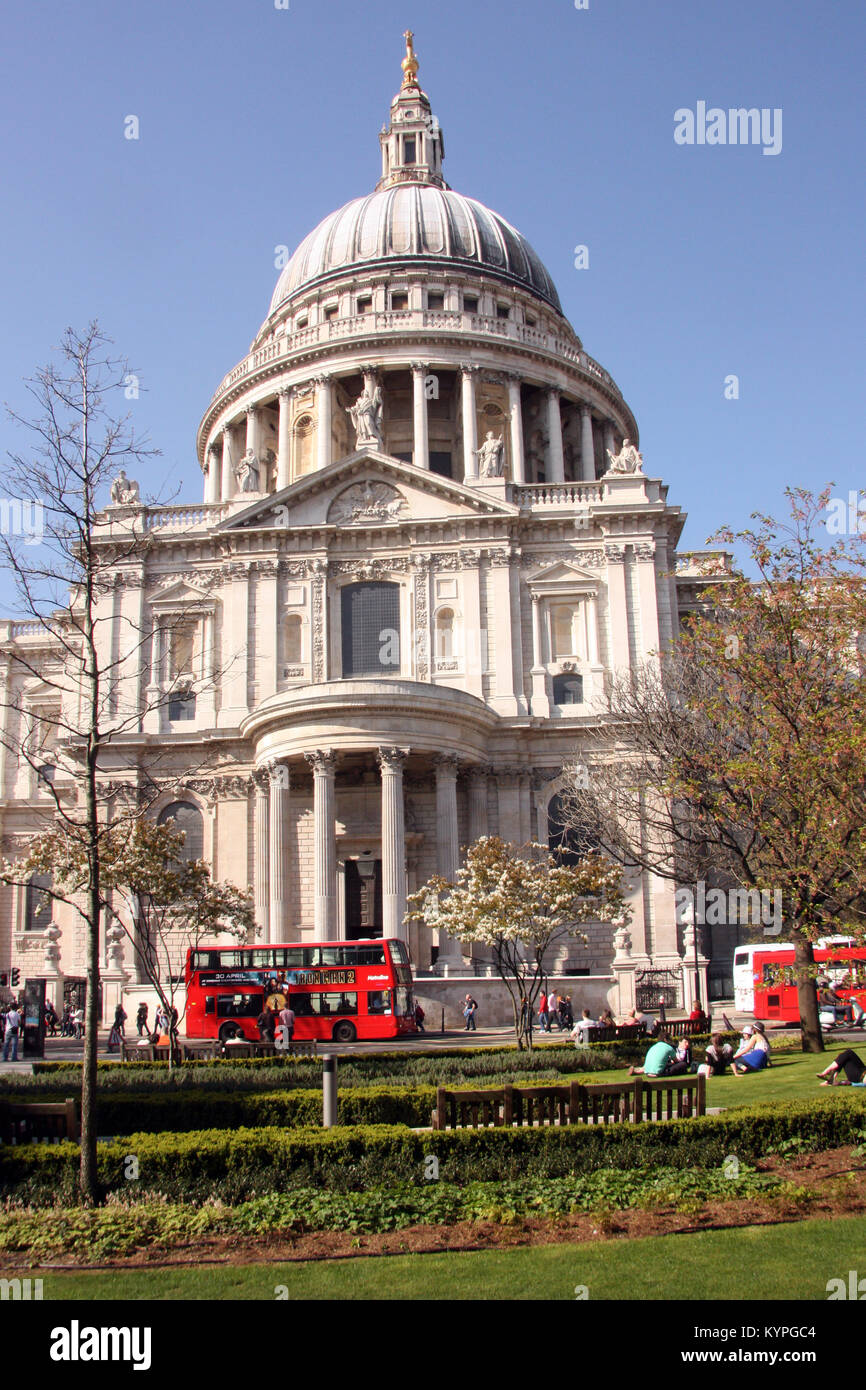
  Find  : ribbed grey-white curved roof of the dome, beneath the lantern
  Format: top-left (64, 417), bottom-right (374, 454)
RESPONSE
top-left (270, 182), bottom-right (562, 314)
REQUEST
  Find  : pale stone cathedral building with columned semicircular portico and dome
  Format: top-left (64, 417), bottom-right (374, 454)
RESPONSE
top-left (0, 40), bottom-right (717, 1022)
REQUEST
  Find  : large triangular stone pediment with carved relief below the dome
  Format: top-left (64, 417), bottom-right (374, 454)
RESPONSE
top-left (217, 449), bottom-right (518, 531)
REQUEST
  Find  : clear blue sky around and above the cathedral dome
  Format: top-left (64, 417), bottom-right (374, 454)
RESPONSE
top-left (0, 0), bottom-right (866, 598)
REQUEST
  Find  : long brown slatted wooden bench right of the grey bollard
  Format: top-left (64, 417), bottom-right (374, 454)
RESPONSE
top-left (431, 1076), bottom-right (706, 1130)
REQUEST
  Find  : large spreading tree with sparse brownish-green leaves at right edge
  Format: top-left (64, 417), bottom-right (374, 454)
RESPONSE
top-left (563, 489), bottom-right (866, 1052)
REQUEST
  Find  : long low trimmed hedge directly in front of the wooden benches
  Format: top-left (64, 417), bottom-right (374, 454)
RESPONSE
top-left (0, 1094), bottom-right (866, 1205)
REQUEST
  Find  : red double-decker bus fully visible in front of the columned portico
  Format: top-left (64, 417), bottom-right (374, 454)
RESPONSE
top-left (186, 937), bottom-right (417, 1043)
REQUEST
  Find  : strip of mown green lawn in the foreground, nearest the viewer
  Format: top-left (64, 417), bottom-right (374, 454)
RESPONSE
top-left (33, 1216), bottom-right (866, 1301)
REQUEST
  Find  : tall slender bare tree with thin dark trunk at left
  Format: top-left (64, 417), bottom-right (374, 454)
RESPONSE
top-left (0, 324), bottom-right (233, 1201)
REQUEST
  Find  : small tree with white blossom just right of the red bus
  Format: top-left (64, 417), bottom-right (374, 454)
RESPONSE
top-left (406, 835), bottom-right (630, 1049)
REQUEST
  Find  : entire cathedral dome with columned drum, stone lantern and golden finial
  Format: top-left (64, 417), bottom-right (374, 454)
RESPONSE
top-left (199, 35), bottom-right (638, 503)
